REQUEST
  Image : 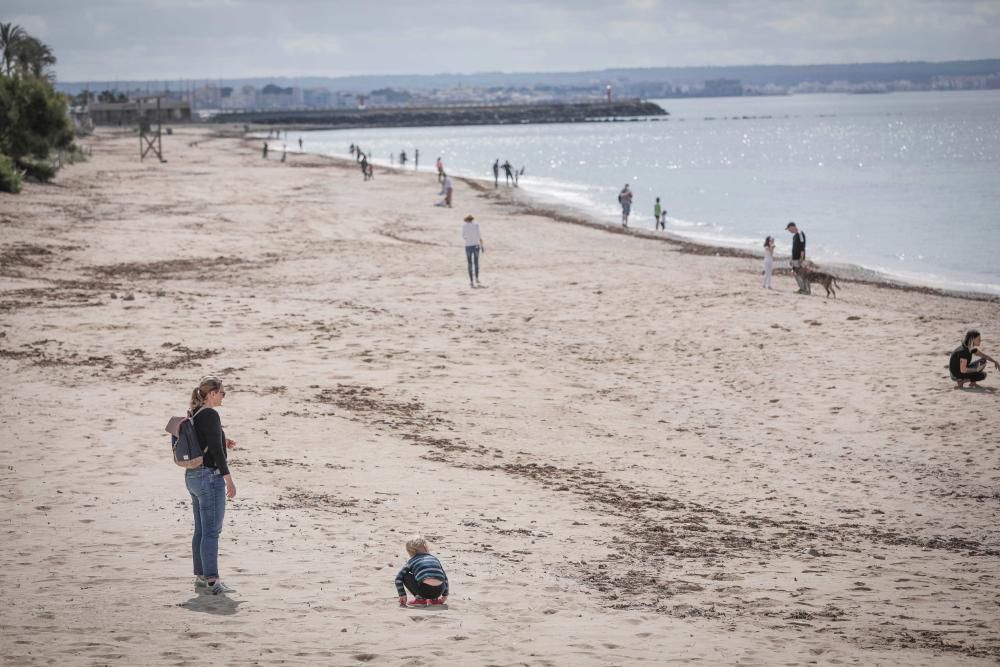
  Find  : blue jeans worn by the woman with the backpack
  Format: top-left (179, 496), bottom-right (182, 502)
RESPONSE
top-left (184, 468), bottom-right (226, 579)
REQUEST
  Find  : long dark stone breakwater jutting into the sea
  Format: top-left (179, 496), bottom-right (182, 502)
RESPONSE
top-left (213, 100), bottom-right (668, 129)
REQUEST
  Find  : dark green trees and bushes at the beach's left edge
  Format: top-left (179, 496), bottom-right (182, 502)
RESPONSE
top-left (0, 23), bottom-right (73, 192)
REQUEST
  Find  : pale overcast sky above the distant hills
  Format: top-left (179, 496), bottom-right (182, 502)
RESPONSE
top-left (7, 0), bottom-right (1000, 81)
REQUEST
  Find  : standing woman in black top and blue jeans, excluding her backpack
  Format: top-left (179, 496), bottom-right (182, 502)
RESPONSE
top-left (184, 376), bottom-right (236, 595)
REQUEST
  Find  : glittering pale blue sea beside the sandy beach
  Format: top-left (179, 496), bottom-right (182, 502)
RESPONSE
top-left (289, 91), bottom-right (1000, 294)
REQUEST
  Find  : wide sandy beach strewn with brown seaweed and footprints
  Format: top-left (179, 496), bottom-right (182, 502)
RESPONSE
top-left (0, 129), bottom-right (1000, 667)
